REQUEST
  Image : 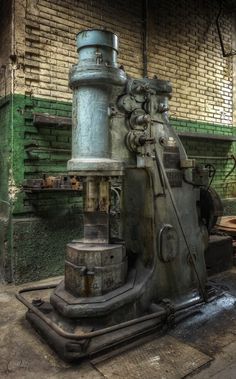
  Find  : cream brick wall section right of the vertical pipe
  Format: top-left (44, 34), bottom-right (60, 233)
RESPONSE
top-left (148, 0), bottom-right (232, 124)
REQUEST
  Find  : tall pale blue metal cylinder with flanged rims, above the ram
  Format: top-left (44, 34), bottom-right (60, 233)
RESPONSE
top-left (68, 30), bottom-right (126, 176)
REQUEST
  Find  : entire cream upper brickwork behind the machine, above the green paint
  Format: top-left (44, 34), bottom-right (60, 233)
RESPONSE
top-left (16, 0), bottom-right (232, 124)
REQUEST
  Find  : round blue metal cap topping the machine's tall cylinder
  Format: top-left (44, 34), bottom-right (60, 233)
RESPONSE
top-left (77, 29), bottom-right (118, 52)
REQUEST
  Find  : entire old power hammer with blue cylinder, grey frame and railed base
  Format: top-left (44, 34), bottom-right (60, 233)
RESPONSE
top-left (17, 30), bottom-right (221, 360)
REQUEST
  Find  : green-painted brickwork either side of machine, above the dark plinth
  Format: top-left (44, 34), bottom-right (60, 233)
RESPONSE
top-left (10, 95), bottom-right (236, 215)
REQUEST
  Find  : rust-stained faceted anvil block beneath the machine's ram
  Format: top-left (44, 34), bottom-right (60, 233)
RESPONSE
top-left (65, 242), bottom-right (127, 297)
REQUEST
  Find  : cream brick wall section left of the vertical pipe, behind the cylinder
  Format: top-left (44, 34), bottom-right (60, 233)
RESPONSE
top-left (16, 0), bottom-right (142, 100)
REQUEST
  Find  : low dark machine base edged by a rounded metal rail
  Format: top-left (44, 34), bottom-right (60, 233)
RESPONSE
top-left (17, 287), bottom-right (220, 362)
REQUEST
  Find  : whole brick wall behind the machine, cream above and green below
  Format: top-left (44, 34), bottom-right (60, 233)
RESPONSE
top-left (0, 0), bottom-right (236, 282)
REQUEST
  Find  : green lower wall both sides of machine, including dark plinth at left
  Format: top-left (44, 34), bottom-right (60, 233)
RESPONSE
top-left (0, 95), bottom-right (236, 283)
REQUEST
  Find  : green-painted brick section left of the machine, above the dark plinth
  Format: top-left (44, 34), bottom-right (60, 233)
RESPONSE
top-left (12, 95), bottom-right (81, 216)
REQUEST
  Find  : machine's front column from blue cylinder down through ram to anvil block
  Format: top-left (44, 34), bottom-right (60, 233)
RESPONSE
top-left (65, 30), bottom-right (127, 297)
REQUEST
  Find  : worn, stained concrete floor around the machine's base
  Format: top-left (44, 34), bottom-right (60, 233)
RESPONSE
top-left (0, 269), bottom-right (236, 379)
